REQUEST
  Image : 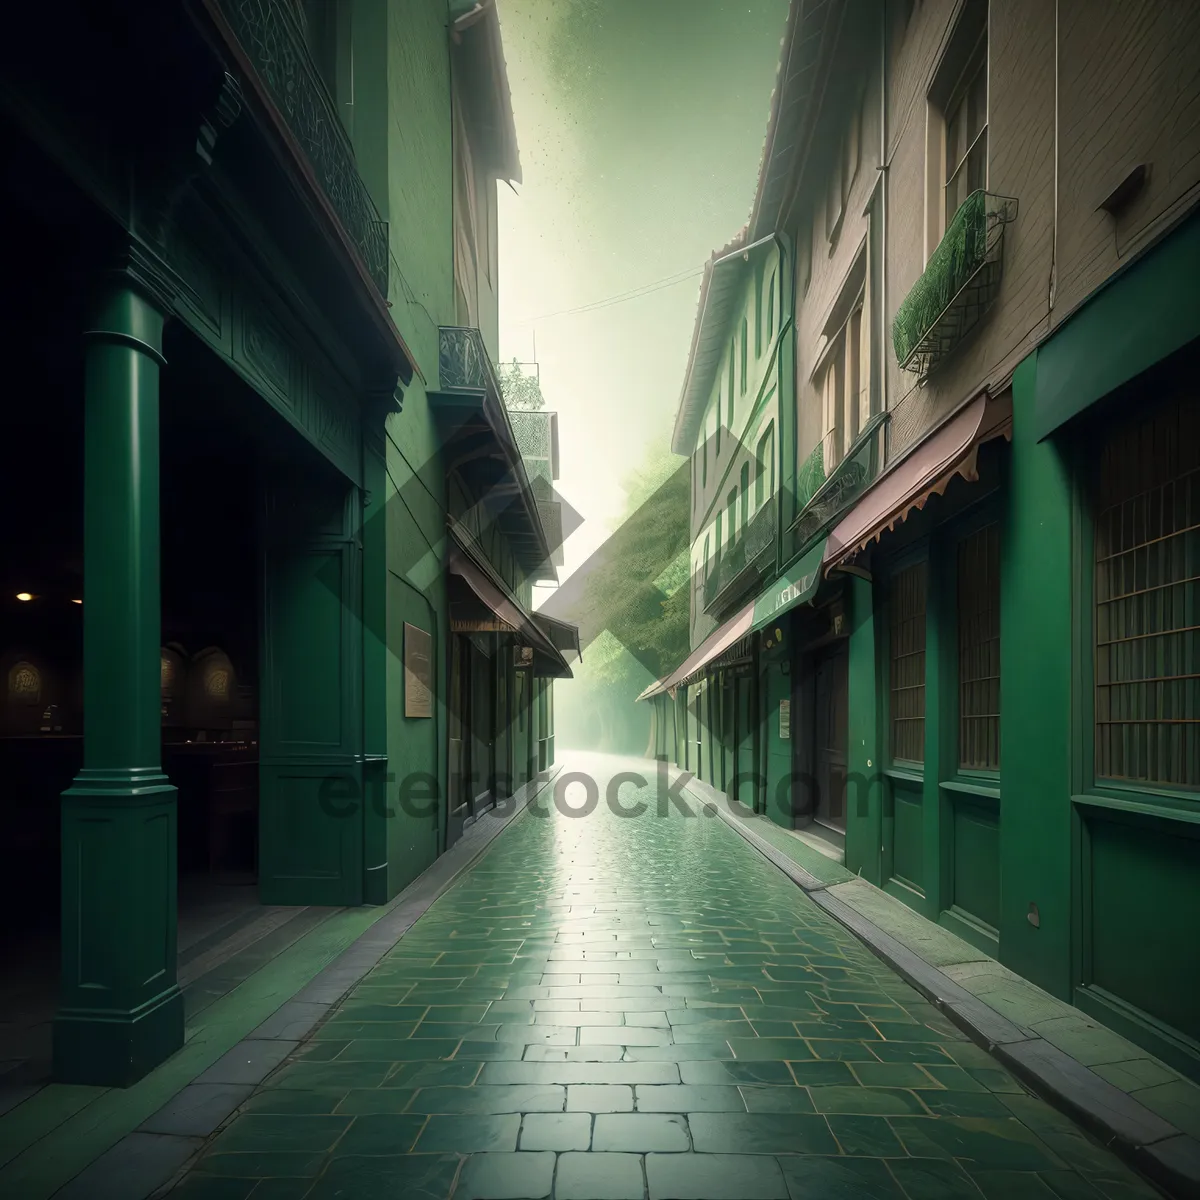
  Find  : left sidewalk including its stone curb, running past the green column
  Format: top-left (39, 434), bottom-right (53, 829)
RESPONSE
top-left (0, 767), bottom-right (560, 1200)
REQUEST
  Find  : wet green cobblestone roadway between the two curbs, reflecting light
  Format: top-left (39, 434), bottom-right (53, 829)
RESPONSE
top-left (172, 756), bottom-right (1157, 1200)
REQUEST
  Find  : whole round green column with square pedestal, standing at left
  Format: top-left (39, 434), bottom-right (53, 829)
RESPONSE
top-left (54, 251), bottom-right (184, 1087)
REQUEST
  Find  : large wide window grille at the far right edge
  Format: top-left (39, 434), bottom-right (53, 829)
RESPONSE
top-left (1094, 397), bottom-right (1200, 788)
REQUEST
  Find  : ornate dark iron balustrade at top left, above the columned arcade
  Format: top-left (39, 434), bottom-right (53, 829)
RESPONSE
top-left (216, 0), bottom-right (390, 299)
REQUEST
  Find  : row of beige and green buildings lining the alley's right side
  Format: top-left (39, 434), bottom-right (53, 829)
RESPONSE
top-left (643, 0), bottom-right (1200, 1078)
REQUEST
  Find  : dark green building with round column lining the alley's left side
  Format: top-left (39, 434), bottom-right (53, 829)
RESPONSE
top-left (0, 0), bottom-right (570, 1085)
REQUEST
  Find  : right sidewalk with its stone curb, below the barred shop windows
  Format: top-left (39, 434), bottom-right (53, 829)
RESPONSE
top-left (686, 767), bottom-right (1200, 1198)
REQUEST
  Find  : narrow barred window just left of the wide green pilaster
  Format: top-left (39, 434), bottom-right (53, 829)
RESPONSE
top-left (959, 524), bottom-right (1000, 770)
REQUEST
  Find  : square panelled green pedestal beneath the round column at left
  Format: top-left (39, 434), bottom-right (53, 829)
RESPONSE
top-left (54, 768), bottom-right (184, 1087)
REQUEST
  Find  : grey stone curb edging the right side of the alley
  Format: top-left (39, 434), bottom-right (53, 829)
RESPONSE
top-left (684, 779), bottom-right (1200, 1200)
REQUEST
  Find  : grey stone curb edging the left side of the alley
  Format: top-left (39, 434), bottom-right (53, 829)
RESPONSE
top-left (54, 766), bottom-right (562, 1200)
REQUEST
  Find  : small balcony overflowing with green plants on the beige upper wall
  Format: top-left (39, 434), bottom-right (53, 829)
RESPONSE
top-left (892, 191), bottom-right (1016, 380)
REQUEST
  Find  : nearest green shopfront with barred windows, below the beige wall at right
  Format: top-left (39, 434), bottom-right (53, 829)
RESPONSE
top-left (833, 204), bottom-right (1200, 1075)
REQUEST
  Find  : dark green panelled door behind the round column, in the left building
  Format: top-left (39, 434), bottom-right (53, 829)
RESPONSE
top-left (259, 472), bottom-right (364, 906)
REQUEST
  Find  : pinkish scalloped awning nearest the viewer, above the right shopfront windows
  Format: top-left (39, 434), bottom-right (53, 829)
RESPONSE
top-left (824, 392), bottom-right (1013, 574)
